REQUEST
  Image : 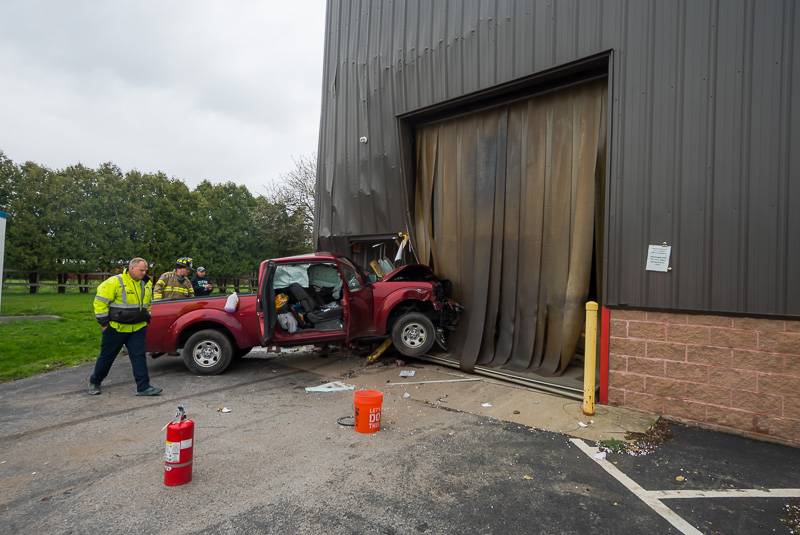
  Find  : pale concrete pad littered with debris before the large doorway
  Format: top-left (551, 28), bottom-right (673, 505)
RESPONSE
top-left (282, 354), bottom-right (658, 441)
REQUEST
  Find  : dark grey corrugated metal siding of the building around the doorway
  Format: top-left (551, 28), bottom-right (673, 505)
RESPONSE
top-left (317, 0), bottom-right (800, 315)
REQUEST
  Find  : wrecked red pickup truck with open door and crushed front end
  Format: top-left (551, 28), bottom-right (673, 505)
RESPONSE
top-left (146, 253), bottom-right (461, 375)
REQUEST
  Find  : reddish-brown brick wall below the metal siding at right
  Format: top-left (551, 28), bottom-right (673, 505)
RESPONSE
top-left (608, 310), bottom-right (800, 446)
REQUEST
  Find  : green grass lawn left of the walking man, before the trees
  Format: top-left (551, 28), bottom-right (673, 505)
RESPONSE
top-left (0, 292), bottom-right (100, 381)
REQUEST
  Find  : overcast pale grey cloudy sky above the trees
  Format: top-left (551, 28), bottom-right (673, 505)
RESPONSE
top-left (0, 0), bottom-right (325, 193)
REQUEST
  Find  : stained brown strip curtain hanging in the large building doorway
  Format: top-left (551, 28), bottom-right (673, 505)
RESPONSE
top-left (414, 80), bottom-right (606, 375)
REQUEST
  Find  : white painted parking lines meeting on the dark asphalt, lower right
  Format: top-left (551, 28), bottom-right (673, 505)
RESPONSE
top-left (570, 438), bottom-right (800, 535)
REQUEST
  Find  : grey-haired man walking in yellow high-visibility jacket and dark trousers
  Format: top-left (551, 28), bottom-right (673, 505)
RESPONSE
top-left (89, 258), bottom-right (161, 396)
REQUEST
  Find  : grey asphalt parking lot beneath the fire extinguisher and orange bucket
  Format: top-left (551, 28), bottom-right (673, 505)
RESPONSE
top-left (0, 353), bottom-right (800, 534)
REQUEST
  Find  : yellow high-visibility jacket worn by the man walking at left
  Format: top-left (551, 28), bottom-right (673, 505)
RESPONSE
top-left (94, 269), bottom-right (153, 333)
